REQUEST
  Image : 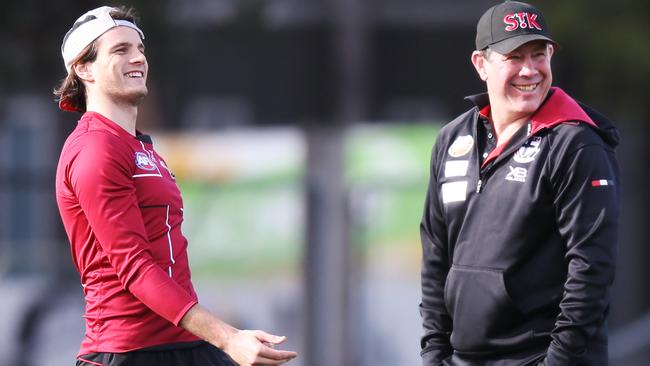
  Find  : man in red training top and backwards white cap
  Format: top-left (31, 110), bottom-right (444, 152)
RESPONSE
top-left (55, 6), bottom-right (296, 366)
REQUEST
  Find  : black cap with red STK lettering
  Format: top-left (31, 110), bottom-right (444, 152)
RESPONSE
top-left (476, 1), bottom-right (557, 53)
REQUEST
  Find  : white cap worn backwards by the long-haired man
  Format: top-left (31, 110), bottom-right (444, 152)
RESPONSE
top-left (61, 6), bottom-right (144, 73)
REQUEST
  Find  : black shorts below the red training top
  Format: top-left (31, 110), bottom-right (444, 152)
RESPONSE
top-left (76, 341), bottom-right (237, 366)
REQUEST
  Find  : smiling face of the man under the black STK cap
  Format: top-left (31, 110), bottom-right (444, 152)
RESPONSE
top-left (472, 41), bottom-right (553, 123)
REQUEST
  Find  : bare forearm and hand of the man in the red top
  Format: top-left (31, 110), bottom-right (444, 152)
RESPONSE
top-left (179, 304), bottom-right (297, 366)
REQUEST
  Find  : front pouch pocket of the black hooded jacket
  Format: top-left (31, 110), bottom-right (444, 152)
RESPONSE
top-left (445, 265), bottom-right (532, 353)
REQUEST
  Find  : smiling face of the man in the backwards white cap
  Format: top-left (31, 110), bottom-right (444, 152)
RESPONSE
top-left (77, 27), bottom-right (149, 105)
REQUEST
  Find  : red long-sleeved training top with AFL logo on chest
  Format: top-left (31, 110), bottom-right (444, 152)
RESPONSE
top-left (56, 112), bottom-right (198, 355)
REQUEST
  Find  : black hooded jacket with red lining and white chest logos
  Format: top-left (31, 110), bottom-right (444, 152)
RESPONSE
top-left (420, 88), bottom-right (620, 366)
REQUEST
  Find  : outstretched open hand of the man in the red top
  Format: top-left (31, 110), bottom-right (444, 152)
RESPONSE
top-left (223, 330), bottom-right (298, 366)
